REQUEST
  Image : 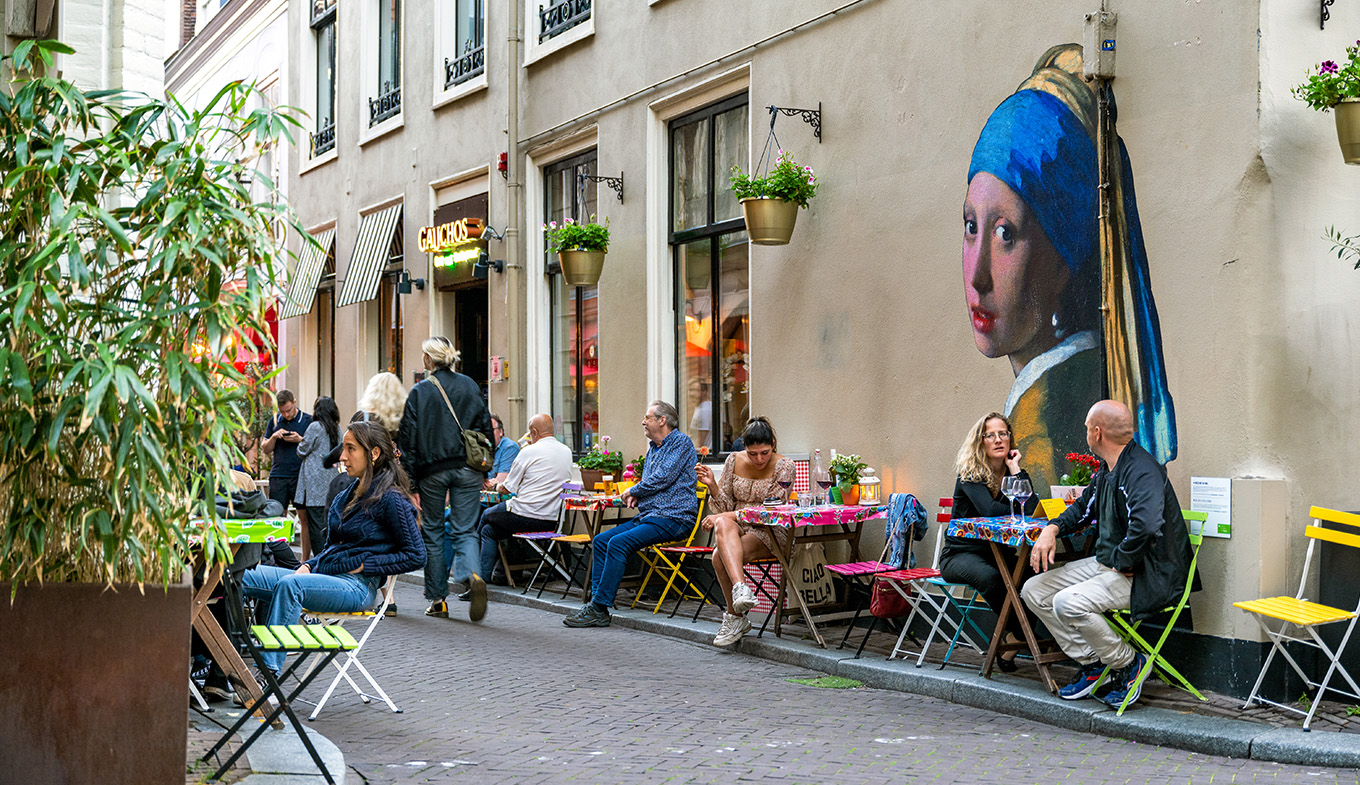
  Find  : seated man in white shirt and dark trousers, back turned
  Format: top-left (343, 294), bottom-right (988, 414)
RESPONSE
top-left (479, 415), bottom-right (571, 585)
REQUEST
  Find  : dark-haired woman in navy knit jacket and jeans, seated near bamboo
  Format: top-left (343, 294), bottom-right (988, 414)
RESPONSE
top-left (242, 422), bottom-right (426, 673)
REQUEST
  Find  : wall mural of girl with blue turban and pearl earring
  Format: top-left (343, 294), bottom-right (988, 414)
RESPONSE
top-left (963, 44), bottom-right (1176, 495)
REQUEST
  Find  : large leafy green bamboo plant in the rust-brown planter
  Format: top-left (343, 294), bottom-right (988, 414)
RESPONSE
top-left (0, 41), bottom-right (306, 590)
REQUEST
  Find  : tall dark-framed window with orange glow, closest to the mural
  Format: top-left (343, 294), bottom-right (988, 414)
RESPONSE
top-left (670, 95), bottom-right (751, 453)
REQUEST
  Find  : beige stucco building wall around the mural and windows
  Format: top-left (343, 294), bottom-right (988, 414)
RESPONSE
top-left (278, 0), bottom-right (1360, 638)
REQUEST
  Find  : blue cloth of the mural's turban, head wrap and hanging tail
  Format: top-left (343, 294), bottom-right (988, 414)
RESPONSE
top-left (968, 90), bottom-right (1176, 464)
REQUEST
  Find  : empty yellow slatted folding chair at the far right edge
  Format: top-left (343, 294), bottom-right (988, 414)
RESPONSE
top-left (1232, 507), bottom-right (1360, 731)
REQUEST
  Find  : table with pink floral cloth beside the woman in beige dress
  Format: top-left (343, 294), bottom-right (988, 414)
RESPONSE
top-left (737, 505), bottom-right (888, 649)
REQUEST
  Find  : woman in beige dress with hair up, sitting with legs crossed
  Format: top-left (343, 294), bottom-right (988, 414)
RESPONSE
top-left (695, 418), bottom-right (794, 646)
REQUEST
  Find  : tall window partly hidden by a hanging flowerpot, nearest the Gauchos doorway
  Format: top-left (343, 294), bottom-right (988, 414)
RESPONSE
top-left (543, 150), bottom-right (600, 453)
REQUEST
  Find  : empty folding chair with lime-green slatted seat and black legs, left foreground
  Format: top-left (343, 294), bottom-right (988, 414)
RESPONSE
top-left (201, 560), bottom-right (359, 785)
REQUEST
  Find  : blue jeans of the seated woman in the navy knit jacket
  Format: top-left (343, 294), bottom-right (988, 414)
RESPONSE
top-left (241, 565), bottom-right (381, 673)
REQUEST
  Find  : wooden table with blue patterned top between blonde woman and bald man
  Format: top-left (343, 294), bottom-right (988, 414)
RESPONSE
top-left (947, 516), bottom-right (1068, 692)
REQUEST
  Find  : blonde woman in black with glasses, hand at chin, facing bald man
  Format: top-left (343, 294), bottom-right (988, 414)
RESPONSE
top-left (940, 412), bottom-right (1039, 673)
